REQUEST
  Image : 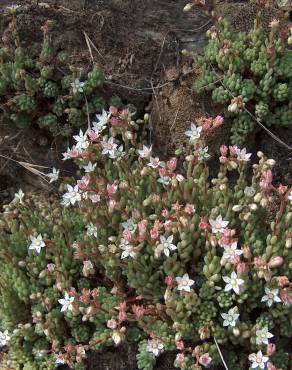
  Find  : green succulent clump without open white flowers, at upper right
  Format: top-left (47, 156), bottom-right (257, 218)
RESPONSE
top-left (193, 15), bottom-right (292, 146)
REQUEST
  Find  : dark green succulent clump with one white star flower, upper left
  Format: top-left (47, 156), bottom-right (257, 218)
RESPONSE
top-left (0, 13), bottom-right (105, 136)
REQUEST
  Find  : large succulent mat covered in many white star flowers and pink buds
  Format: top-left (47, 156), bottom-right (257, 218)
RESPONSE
top-left (0, 107), bottom-right (292, 370)
